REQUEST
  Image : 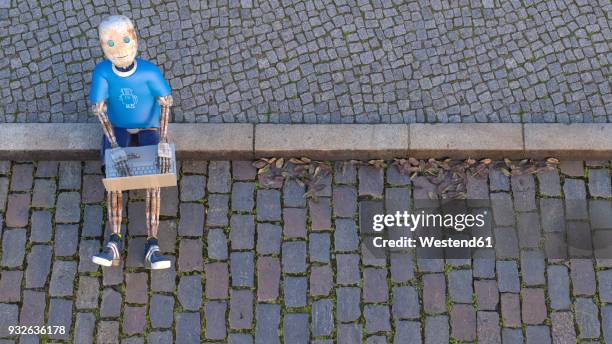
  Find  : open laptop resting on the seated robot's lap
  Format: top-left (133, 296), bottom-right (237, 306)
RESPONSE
top-left (102, 144), bottom-right (176, 191)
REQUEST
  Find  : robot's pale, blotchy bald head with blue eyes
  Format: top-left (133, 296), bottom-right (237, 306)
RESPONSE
top-left (98, 15), bottom-right (138, 68)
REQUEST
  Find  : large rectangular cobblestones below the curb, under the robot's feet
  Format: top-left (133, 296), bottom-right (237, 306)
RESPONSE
top-left (0, 161), bottom-right (612, 344)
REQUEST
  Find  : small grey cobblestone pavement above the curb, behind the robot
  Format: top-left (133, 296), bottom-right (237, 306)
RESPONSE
top-left (0, 0), bottom-right (612, 123)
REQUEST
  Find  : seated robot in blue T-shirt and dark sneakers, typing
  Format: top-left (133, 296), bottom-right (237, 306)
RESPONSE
top-left (89, 15), bottom-right (172, 269)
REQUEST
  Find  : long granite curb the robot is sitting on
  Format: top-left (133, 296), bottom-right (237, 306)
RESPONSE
top-left (0, 123), bottom-right (612, 160)
